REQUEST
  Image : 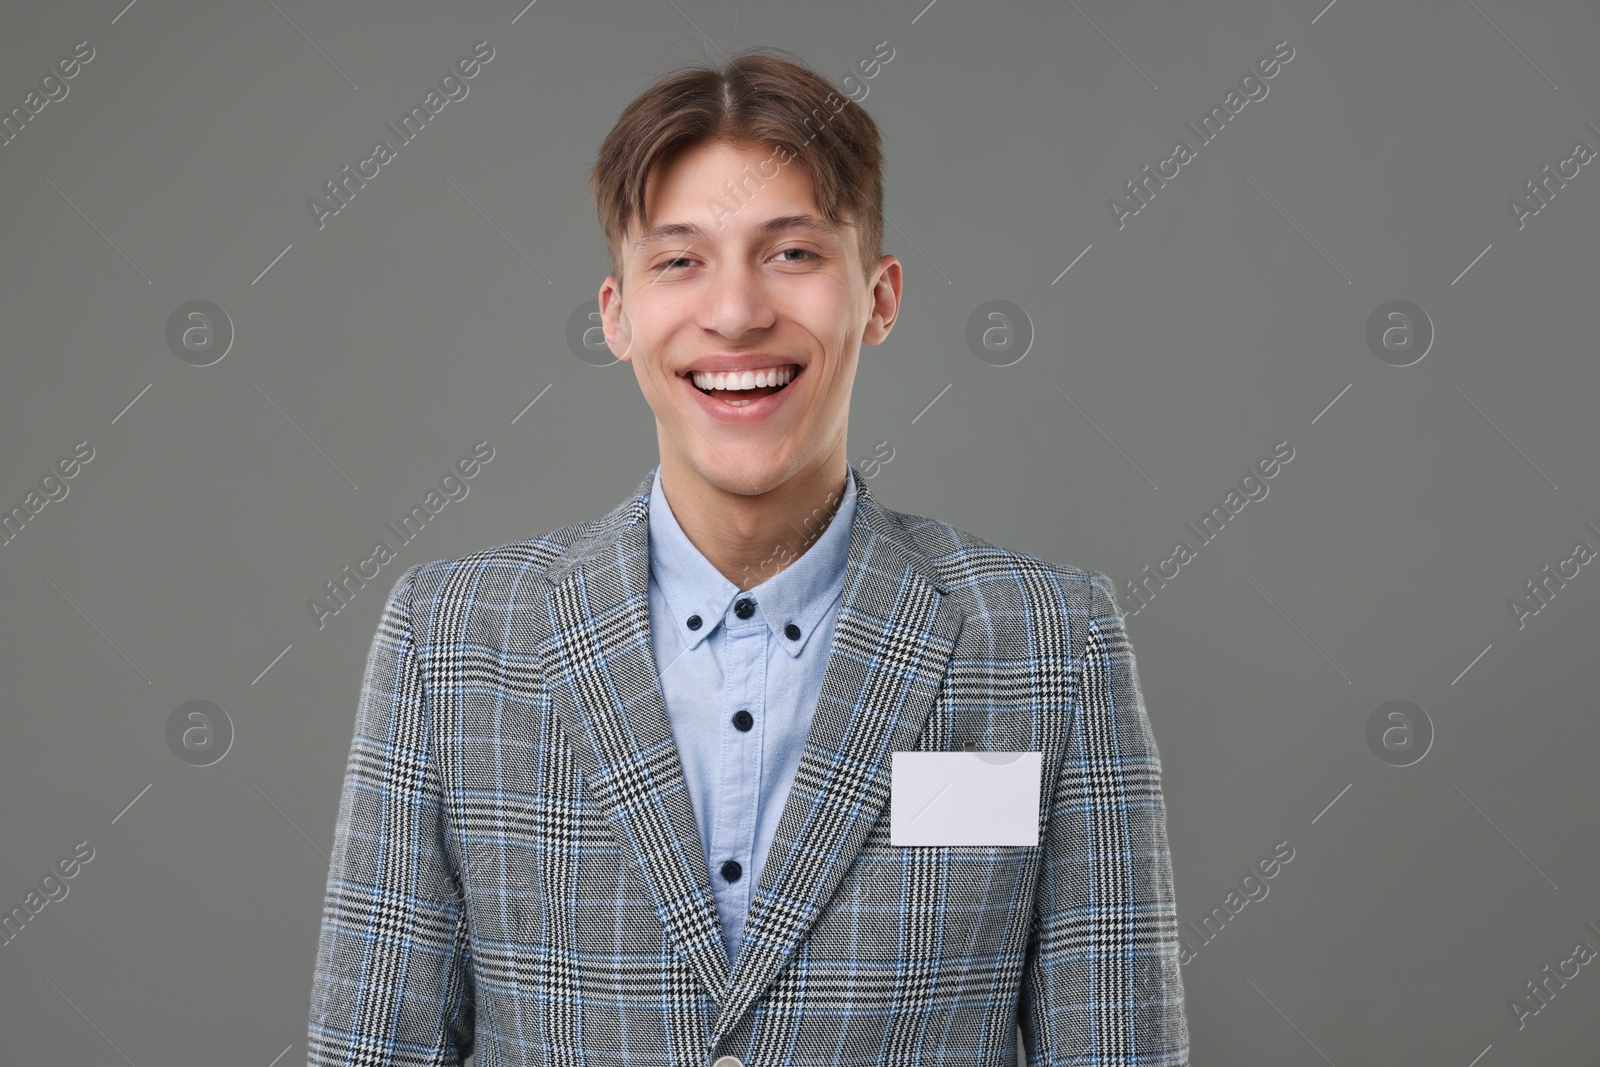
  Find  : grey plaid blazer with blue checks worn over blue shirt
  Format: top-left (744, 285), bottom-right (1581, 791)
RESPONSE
top-left (307, 467), bottom-right (1189, 1067)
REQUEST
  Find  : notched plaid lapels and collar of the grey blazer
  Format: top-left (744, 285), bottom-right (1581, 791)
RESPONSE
top-left (536, 467), bottom-right (965, 1040)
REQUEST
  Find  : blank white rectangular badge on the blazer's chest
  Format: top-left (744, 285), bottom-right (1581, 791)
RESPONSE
top-left (890, 752), bottom-right (1043, 845)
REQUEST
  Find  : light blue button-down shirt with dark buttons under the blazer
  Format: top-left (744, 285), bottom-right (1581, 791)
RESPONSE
top-left (650, 466), bottom-right (856, 963)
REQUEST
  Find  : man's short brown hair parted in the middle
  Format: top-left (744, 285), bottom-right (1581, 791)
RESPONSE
top-left (589, 48), bottom-right (883, 292)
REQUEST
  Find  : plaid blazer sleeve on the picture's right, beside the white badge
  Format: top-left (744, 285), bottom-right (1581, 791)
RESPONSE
top-left (1018, 573), bottom-right (1189, 1067)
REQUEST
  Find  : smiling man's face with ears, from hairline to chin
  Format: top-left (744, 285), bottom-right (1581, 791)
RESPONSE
top-left (600, 135), bottom-right (901, 496)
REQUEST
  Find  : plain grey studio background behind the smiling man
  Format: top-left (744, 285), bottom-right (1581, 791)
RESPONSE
top-left (0, 0), bottom-right (1600, 1067)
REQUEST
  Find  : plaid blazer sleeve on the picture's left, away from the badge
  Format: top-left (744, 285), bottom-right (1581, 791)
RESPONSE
top-left (306, 565), bottom-right (474, 1067)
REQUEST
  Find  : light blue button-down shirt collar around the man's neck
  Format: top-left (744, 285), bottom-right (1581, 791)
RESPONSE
top-left (650, 464), bottom-right (856, 657)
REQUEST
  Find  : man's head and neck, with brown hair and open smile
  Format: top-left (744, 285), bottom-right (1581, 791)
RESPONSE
top-left (590, 87), bottom-right (901, 589)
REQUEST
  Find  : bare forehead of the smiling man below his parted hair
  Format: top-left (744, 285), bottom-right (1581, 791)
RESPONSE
top-left (627, 142), bottom-right (853, 254)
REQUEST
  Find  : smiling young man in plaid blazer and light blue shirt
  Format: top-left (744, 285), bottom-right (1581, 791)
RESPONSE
top-left (309, 45), bottom-right (1189, 1067)
